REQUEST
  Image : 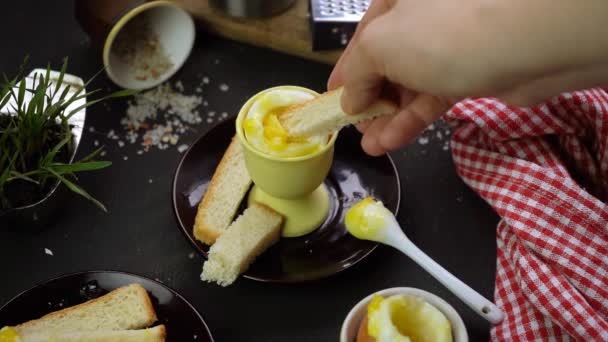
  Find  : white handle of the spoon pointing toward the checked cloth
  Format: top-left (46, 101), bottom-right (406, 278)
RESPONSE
top-left (391, 234), bottom-right (504, 324)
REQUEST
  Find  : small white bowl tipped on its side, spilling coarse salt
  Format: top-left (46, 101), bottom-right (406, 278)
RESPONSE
top-left (103, 1), bottom-right (196, 90)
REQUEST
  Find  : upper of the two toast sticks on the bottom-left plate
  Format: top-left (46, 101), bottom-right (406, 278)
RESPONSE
top-left (14, 284), bottom-right (157, 338)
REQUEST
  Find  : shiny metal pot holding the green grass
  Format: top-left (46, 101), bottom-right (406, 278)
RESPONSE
top-left (0, 69), bottom-right (86, 229)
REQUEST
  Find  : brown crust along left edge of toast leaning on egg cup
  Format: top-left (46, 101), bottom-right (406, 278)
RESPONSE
top-left (194, 136), bottom-right (245, 245)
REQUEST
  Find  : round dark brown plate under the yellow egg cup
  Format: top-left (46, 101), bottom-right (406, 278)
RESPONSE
top-left (173, 118), bottom-right (401, 283)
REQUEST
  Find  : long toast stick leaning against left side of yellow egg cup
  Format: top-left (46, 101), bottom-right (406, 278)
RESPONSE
top-left (194, 137), bottom-right (251, 245)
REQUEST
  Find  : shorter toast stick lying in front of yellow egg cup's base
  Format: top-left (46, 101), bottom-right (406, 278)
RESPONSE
top-left (201, 203), bottom-right (283, 286)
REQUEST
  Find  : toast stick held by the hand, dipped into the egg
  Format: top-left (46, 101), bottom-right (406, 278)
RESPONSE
top-left (279, 87), bottom-right (397, 136)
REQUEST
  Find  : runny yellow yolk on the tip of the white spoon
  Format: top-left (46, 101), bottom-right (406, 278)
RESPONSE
top-left (344, 197), bottom-right (391, 240)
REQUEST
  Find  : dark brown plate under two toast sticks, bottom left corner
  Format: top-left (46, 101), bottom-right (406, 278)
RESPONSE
top-left (0, 271), bottom-right (213, 342)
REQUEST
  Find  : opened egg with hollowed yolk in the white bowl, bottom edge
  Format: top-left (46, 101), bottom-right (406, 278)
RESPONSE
top-left (367, 295), bottom-right (452, 342)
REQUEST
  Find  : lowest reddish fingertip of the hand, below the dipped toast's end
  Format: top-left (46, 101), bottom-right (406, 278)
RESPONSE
top-left (380, 94), bottom-right (450, 151)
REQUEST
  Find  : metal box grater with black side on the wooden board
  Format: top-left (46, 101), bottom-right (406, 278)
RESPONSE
top-left (310, 0), bottom-right (370, 51)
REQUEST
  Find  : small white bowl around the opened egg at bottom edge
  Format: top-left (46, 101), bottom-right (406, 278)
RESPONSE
top-left (340, 287), bottom-right (469, 342)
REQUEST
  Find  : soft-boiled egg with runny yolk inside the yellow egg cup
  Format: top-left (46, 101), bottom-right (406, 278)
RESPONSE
top-left (243, 88), bottom-right (329, 158)
